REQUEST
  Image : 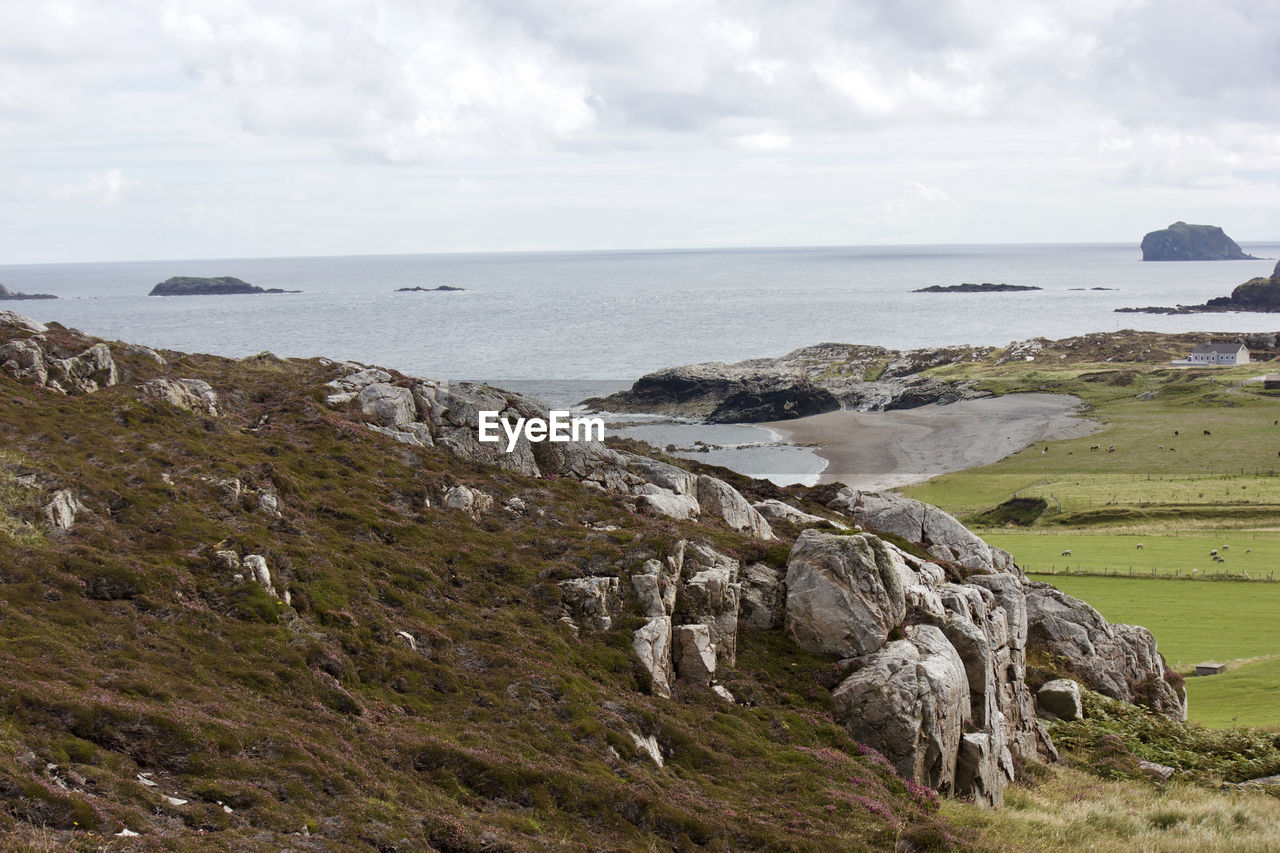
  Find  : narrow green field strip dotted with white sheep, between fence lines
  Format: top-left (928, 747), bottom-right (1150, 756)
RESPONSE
top-left (979, 532), bottom-right (1280, 578)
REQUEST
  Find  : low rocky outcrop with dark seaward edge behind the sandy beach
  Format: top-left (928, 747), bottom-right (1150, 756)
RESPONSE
top-left (586, 343), bottom-right (988, 423)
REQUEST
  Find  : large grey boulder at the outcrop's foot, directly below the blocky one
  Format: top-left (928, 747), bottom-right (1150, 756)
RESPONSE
top-left (832, 625), bottom-right (969, 793)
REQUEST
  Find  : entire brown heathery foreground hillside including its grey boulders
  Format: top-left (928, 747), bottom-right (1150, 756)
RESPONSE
top-left (0, 313), bottom-right (1213, 850)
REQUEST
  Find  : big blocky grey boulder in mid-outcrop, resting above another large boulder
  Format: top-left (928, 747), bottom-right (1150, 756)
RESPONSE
top-left (786, 530), bottom-right (915, 657)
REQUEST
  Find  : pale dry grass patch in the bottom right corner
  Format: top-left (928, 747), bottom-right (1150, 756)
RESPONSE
top-left (943, 767), bottom-right (1280, 853)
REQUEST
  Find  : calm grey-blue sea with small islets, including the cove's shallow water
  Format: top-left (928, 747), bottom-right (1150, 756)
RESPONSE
top-left (0, 242), bottom-right (1280, 482)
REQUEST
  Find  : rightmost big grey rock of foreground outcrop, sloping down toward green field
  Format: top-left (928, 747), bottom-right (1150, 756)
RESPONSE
top-left (1027, 581), bottom-right (1187, 720)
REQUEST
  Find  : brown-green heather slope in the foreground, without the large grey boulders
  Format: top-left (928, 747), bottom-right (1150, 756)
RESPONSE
top-left (0, 322), bottom-right (962, 850)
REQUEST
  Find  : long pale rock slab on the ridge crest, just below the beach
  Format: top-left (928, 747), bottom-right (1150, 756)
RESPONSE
top-left (831, 488), bottom-right (1014, 571)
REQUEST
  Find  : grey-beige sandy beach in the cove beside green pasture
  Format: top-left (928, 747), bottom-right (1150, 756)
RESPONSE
top-left (762, 394), bottom-right (1100, 491)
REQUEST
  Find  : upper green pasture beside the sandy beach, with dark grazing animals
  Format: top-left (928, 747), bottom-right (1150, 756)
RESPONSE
top-left (904, 365), bottom-right (1280, 526)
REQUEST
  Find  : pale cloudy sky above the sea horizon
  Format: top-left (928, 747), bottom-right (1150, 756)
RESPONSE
top-left (0, 0), bottom-right (1280, 264)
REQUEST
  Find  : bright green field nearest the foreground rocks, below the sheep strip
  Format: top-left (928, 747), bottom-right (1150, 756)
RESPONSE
top-left (1034, 575), bottom-right (1280, 727)
